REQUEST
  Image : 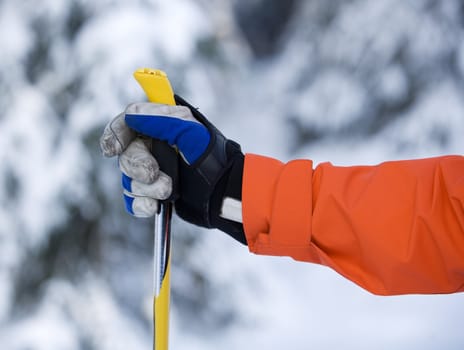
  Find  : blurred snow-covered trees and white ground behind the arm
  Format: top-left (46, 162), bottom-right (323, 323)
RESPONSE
top-left (0, 0), bottom-right (464, 350)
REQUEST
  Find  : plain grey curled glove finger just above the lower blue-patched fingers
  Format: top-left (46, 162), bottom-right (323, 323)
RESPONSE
top-left (119, 138), bottom-right (160, 184)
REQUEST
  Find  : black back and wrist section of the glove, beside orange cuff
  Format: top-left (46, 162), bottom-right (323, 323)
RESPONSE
top-left (174, 95), bottom-right (246, 245)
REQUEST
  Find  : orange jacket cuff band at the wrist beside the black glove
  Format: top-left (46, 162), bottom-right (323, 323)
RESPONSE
top-left (242, 154), bottom-right (318, 261)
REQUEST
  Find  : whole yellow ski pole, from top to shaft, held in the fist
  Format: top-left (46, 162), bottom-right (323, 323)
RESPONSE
top-left (134, 68), bottom-right (177, 350)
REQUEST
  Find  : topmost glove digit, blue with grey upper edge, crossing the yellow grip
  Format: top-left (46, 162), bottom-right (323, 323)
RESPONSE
top-left (125, 103), bottom-right (211, 164)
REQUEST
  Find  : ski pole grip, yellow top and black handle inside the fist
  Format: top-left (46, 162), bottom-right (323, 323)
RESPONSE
top-left (134, 68), bottom-right (179, 202)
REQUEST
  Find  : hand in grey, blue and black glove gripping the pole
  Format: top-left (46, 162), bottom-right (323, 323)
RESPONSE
top-left (100, 96), bottom-right (246, 244)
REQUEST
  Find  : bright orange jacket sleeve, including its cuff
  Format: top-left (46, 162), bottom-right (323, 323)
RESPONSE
top-left (242, 154), bottom-right (464, 295)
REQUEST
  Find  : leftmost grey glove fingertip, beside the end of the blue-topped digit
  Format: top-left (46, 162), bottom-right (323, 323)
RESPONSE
top-left (100, 113), bottom-right (136, 157)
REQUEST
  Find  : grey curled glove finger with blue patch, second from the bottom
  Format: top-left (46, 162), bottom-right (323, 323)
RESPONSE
top-left (122, 172), bottom-right (172, 200)
